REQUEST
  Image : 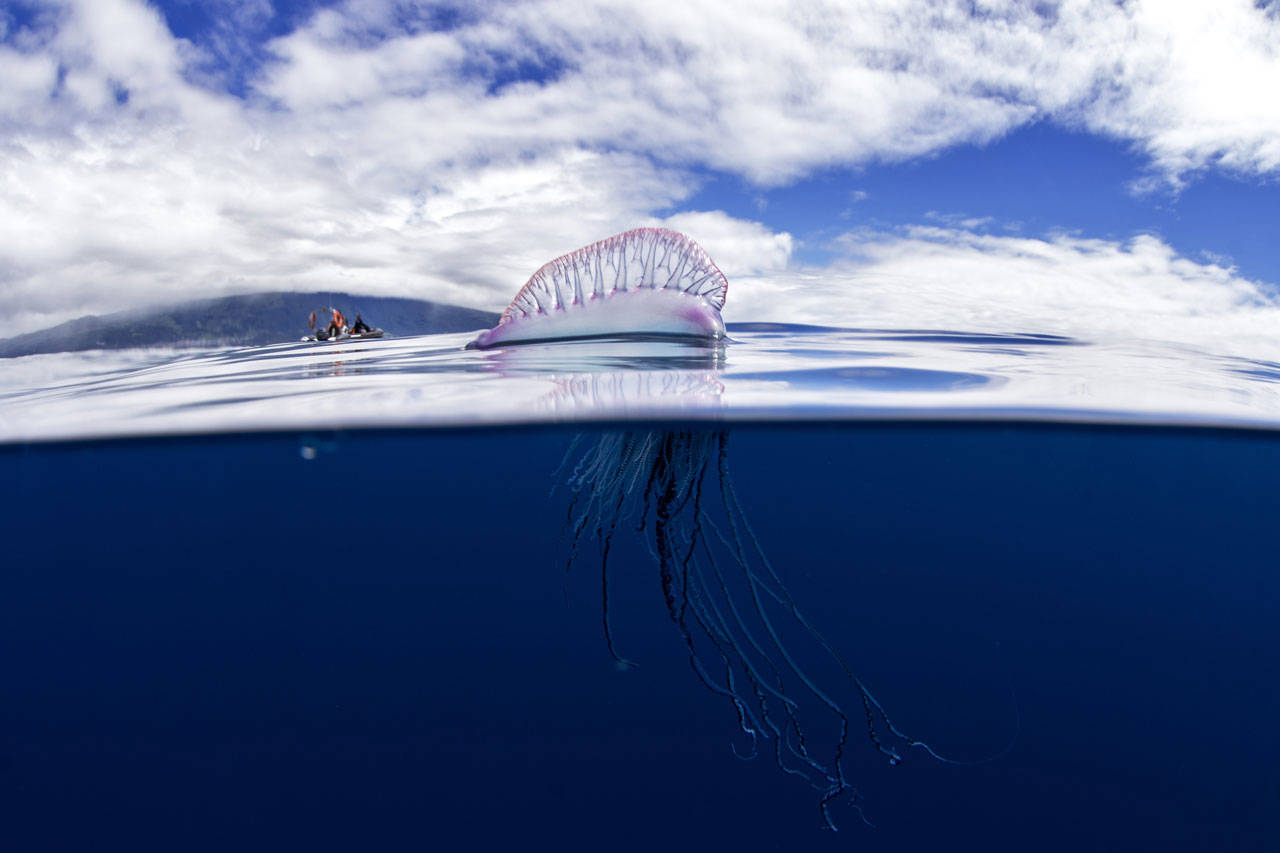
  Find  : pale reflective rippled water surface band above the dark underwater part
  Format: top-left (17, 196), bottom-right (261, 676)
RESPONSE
top-left (0, 324), bottom-right (1280, 442)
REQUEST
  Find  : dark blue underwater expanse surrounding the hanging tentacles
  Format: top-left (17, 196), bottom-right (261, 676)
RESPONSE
top-left (0, 424), bottom-right (1280, 850)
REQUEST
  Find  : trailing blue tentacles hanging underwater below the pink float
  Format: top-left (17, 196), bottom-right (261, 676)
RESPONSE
top-left (566, 430), bottom-right (938, 830)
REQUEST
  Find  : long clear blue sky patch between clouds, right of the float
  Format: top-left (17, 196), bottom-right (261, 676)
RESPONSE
top-left (687, 123), bottom-right (1280, 282)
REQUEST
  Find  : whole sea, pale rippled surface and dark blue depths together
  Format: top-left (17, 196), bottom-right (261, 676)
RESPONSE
top-left (0, 324), bottom-right (1280, 852)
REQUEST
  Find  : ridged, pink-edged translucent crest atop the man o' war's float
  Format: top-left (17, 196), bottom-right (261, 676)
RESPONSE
top-left (499, 228), bottom-right (728, 325)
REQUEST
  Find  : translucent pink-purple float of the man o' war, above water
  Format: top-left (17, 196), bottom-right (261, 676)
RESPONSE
top-left (468, 228), bottom-right (728, 348)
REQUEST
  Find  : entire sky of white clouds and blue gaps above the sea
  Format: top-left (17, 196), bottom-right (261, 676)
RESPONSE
top-left (0, 0), bottom-right (1280, 346)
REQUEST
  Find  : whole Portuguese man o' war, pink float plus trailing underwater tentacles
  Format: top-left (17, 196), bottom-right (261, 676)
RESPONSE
top-left (468, 228), bottom-right (972, 830)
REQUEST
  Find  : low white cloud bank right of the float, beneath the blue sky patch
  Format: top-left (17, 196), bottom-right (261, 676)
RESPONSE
top-left (724, 225), bottom-right (1280, 359)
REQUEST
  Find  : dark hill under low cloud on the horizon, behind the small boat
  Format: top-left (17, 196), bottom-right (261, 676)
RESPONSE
top-left (0, 293), bottom-right (498, 359)
